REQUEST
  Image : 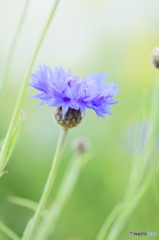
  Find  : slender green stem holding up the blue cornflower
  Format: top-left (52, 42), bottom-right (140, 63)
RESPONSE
top-left (22, 128), bottom-right (67, 240)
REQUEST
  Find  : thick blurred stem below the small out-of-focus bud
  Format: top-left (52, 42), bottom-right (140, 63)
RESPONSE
top-left (35, 153), bottom-right (90, 240)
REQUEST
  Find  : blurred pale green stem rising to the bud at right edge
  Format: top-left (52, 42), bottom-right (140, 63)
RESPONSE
top-left (103, 70), bottom-right (159, 240)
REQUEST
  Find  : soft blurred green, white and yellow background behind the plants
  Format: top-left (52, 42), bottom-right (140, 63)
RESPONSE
top-left (0, 0), bottom-right (159, 240)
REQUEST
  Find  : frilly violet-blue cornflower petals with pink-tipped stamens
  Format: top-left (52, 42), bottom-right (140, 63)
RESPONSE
top-left (29, 65), bottom-right (118, 118)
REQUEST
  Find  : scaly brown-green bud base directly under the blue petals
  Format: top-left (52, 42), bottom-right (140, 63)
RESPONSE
top-left (54, 107), bottom-right (82, 129)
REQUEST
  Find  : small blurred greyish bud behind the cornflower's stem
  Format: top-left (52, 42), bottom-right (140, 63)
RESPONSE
top-left (72, 137), bottom-right (91, 154)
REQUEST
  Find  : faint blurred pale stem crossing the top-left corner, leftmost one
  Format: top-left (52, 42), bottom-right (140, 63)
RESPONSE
top-left (0, 0), bottom-right (30, 102)
